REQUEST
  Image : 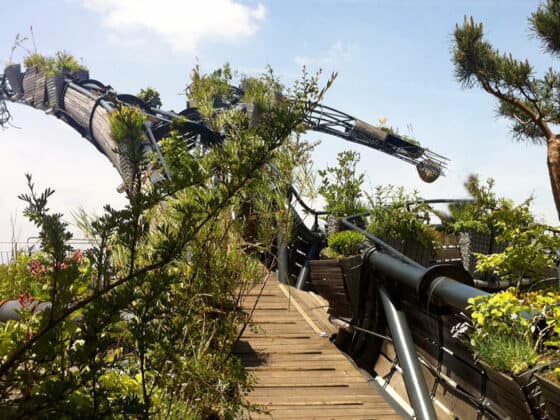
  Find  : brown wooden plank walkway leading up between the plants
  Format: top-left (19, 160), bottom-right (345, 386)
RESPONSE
top-left (236, 278), bottom-right (401, 419)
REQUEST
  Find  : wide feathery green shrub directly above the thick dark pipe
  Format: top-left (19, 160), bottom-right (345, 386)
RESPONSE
top-left (368, 185), bottom-right (440, 251)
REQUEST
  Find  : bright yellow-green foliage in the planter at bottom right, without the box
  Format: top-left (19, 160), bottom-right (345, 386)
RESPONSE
top-left (467, 288), bottom-right (560, 374)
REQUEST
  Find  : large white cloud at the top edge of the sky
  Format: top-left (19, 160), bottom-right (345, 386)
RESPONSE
top-left (78, 0), bottom-right (265, 52)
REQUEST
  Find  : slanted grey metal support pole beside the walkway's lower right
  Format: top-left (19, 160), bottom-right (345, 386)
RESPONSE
top-left (379, 286), bottom-right (437, 420)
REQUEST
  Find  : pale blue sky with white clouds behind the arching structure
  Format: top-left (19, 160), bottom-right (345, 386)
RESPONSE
top-left (0, 0), bottom-right (558, 246)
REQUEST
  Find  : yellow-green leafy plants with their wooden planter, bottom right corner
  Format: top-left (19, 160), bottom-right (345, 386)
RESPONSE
top-left (467, 288), bottom-right (560, 414)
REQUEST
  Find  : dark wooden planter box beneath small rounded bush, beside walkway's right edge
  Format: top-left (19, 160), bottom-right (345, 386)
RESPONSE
top-left (310, 255), bottom-right (362, 318)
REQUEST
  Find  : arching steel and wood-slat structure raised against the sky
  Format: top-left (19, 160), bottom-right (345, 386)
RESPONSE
top-left (0, 65), bottom-right (448, 182)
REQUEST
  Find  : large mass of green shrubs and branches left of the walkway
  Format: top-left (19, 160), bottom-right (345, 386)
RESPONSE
top-left (0, 62), bottom-right (323, 419)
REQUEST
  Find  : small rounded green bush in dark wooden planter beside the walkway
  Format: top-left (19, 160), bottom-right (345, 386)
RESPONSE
top-left (311, 230), bottom-right (365, 318)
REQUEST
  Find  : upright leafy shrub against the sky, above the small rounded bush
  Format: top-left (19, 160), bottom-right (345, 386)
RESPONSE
top-left (318, 151), bottom-right (365, 217)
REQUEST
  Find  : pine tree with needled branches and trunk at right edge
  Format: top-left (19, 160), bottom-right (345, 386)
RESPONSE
top-left (453, 0), bottom-right (560, 218)
